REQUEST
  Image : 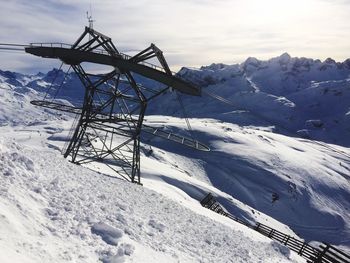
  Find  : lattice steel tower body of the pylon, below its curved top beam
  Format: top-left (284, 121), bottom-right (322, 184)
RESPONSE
top-left (64, 65), bottom-right (147, 184)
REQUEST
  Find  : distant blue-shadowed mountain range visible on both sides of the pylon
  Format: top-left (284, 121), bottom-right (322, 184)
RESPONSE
top-left (0, 53), bottom-right (350, 146)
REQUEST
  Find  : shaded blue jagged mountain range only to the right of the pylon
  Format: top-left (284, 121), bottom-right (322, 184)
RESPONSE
top-left (174, 53), bottom-right (350, 146)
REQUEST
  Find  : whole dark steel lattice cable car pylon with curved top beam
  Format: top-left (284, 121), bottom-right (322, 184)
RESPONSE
top-left (25, 27), bottom-right (209, 183)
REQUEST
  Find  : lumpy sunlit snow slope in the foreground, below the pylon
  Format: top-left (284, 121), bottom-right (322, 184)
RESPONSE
top-left (0, 122), bottom-right (304, 262)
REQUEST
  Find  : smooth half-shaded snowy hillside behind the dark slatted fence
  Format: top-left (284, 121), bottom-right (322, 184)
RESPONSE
top-left (139, 117), bottom-right (350, 250)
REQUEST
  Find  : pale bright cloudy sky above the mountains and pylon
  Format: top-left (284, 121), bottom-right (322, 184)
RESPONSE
top-left (0, 0), bottom-right (350, 73)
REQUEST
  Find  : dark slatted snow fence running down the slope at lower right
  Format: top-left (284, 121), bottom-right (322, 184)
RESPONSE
top-left (200, 193), bottom-right (350, 263)
